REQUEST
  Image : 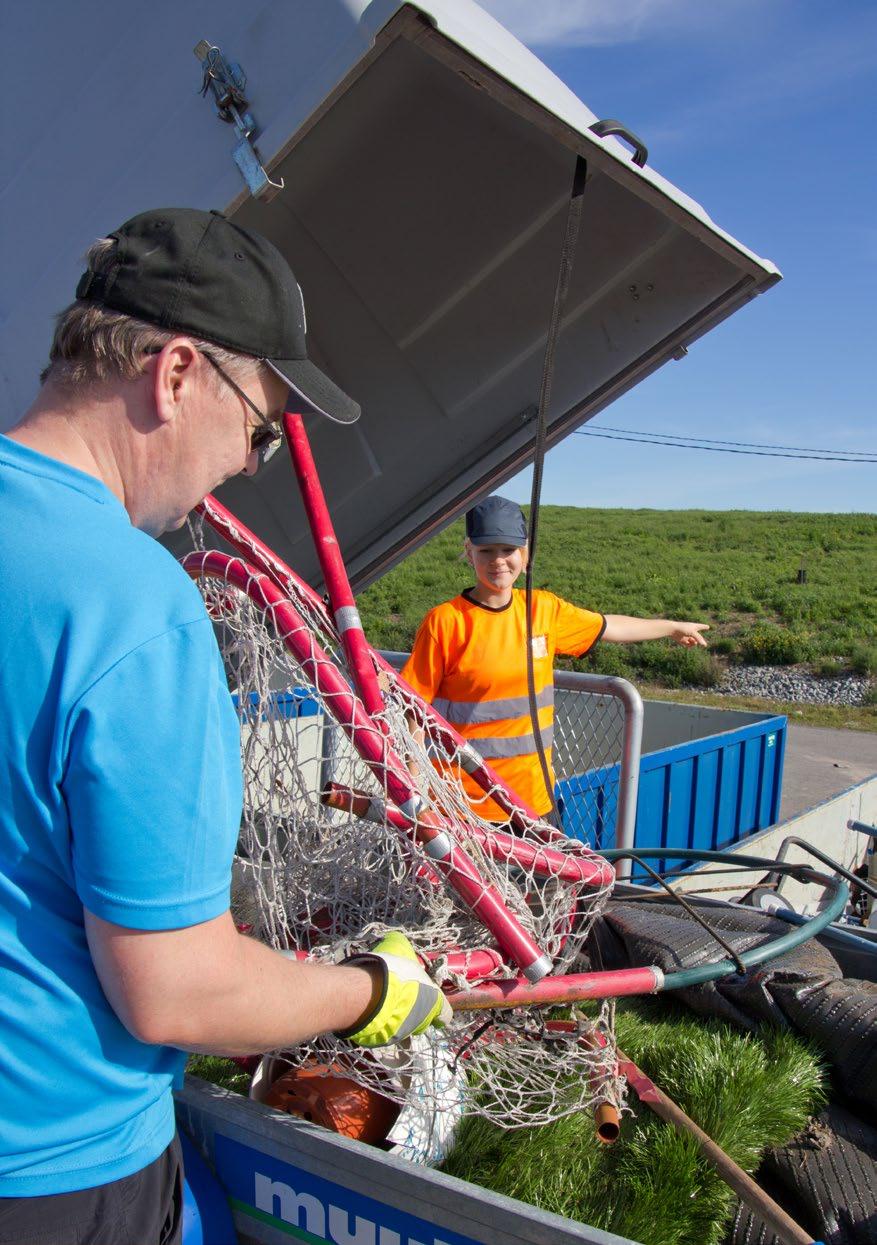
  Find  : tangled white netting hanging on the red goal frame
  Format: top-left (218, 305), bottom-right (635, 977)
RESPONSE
top-left (188, 510), bottom-right (622, 1127)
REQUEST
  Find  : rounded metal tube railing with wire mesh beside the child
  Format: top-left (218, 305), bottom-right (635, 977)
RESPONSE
top-left (381, 651), bottom-right (643, 878)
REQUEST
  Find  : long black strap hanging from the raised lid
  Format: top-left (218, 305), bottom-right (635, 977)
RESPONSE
top-left (526, 156), bottom-right (588, 812)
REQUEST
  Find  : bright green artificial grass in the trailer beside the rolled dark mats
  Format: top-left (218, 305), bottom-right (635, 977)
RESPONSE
top-left (443, 1001), bottom-right (825, 1245)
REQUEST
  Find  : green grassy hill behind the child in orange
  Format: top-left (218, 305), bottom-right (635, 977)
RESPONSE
top-left (359, 505), bottom-right (877, 686)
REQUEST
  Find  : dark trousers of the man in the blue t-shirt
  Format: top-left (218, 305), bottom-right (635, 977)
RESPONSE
top-left (0, 1137), bottom-right (183, 1245)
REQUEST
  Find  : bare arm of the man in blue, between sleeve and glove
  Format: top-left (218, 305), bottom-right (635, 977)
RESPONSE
top-left (85, 909), bottom-right (382, 1055)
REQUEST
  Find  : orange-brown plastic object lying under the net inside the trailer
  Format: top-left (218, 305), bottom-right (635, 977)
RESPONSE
top-left (264, 1063), bottom-right (399, 1145)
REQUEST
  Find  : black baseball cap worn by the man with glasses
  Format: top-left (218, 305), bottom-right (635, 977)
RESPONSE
top-left (76, 208), bottom-right (360, 423)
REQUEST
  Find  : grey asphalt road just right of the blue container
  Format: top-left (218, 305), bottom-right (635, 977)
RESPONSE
top-left (780, 723), bottom-right (877, 820)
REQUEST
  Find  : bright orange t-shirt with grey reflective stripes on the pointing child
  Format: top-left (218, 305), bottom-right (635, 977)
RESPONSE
top-left (402, 589), bottom-right (605, 822)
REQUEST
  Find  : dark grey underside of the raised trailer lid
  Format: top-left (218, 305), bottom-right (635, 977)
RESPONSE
top-left (160, 7), bottom-right (779, 586)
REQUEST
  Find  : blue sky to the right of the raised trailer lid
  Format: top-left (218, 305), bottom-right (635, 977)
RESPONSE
top-left (480, 0), bottom-right (877, 512)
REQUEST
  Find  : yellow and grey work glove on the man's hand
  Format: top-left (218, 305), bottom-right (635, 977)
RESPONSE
top-left (338, 930), bottom-right (453, 1046)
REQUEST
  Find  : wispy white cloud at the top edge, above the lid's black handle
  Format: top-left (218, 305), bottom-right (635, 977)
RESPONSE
top-left (478, 0), bottom-right (709, 47)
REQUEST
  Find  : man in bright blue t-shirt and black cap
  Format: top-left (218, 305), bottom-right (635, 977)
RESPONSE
top-left (0, 209), bottom-right (450, 1245)
